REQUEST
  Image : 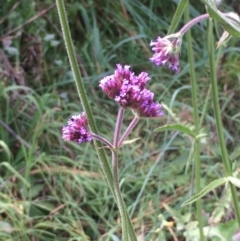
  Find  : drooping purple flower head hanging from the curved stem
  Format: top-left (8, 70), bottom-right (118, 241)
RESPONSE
top-left (150, 35), bottom-right (181, 71)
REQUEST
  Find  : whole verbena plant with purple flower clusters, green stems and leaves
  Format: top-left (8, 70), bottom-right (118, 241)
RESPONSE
top-left (56, 0), bottom-right (240, 241)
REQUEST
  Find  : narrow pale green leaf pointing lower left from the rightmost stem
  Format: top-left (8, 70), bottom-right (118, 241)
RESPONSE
top-left (182, 177), bottom-right (228, 207)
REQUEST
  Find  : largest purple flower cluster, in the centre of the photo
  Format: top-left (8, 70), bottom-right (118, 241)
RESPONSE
top-left (99, 64), bottom-right (163, 117)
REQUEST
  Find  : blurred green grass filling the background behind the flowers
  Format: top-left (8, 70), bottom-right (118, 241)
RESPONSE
top-left (0, 0), bottom-right (240, 241)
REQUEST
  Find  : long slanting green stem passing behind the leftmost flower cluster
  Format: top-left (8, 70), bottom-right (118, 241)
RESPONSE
top-left (56, 0), bottom-right (137, 238)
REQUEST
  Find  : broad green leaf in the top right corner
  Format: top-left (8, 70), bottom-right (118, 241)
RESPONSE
top-left (201, 0), bottom-right (240, 37)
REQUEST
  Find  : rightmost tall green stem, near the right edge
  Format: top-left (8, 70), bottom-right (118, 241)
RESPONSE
top-left (208, 20), bottom-right (240, 227)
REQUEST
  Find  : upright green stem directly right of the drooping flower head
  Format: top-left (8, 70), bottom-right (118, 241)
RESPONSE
top-left (184, 4), bottom-right (205, 241)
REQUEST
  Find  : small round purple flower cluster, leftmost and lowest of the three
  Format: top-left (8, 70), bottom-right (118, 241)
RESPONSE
top-left (62, 112), bottom-right (92, 143)
